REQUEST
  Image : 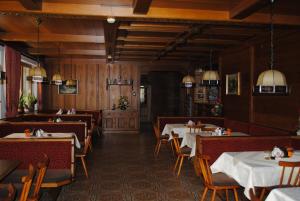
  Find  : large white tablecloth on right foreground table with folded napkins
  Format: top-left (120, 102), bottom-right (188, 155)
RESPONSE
top-left (211, 151), bottom-right (300, 198)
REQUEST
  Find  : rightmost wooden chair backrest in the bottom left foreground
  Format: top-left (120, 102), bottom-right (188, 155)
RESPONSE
top-left (30, 154), bottom-right (49, 200)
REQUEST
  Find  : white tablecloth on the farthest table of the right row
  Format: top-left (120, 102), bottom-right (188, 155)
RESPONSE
top-left (161, 124), bottom-right (217, 140)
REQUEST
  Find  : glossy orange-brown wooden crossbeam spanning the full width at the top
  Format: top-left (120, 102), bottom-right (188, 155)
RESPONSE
top-left (0, 0), bottom-right (300, 26)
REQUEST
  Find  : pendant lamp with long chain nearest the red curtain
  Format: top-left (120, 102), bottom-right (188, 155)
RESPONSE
top-left (29, 17), bottom-right (47, 82)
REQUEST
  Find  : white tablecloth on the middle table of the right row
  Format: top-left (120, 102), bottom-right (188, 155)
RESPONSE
top-left (181, 131), bottom-right (248, 157)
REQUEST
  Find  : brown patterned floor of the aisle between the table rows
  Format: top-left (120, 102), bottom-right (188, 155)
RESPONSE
top-left (43, 125), bottom-right (246, 201)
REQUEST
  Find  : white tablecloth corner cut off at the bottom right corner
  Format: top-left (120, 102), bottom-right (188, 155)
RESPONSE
top-left (265, 187), bottom-right (300, 201)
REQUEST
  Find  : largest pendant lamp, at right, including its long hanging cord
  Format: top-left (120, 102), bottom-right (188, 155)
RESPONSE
top-left (254, 0), bottom-right (288, 95)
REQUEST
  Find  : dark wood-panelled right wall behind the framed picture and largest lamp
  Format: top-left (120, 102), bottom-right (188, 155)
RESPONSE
top-left (220, 31), bottom-right (300, 131)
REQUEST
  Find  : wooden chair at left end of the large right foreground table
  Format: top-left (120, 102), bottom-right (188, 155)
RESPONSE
top-left (197, 155), bottom-right (239, 201)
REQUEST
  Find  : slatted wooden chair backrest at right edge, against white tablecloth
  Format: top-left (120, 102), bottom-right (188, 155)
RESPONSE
top-left (278, 161), bottom-right (300, 186)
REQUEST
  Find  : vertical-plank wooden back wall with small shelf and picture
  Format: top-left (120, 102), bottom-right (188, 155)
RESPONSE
top-left (43, 58), bottom-right (140, 110)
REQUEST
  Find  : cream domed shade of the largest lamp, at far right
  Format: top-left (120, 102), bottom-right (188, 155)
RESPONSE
top-left (256, 70), bottom-right (287, 86)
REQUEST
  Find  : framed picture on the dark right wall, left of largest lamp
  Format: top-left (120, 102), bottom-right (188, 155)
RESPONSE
top-left (226, 72), bottom-right (241, 95)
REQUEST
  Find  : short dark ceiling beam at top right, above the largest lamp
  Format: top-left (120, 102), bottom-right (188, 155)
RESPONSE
top-left (229, 0), bottom-right (270, 19)
